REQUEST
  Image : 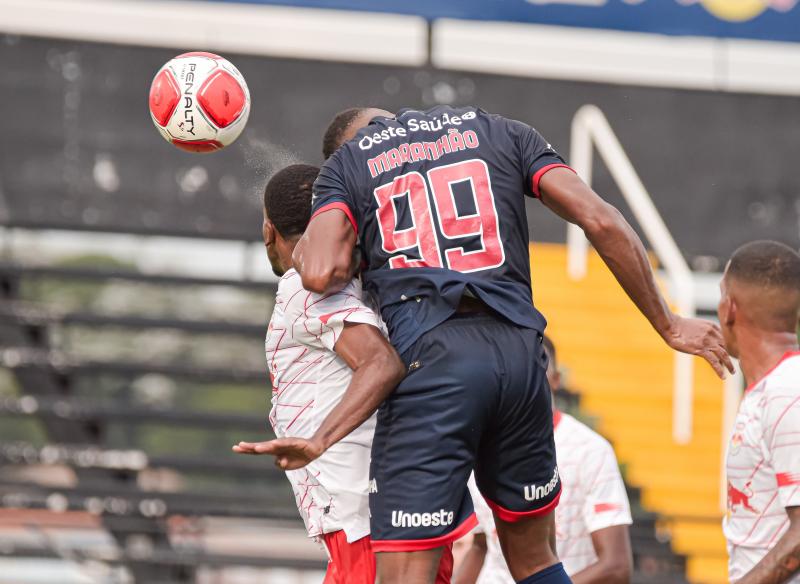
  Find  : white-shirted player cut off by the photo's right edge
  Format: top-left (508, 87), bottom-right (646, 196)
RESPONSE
top-left (719, 242), bottom-right (800, 584)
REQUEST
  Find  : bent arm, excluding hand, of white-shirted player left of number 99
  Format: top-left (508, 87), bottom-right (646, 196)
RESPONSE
top-left (311, 323), bottom-right (406, 450)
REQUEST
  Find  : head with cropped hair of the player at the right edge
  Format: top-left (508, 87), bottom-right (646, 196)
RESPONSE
top-left (719, 241), bottom-right (800, 356)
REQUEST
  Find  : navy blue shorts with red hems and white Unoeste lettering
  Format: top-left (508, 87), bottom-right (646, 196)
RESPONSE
top-left (369, 315), bottom-right (561, 552)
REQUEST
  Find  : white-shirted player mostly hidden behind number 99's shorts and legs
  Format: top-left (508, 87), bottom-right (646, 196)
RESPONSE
top-left (454, 338), bottom-right (632, 584)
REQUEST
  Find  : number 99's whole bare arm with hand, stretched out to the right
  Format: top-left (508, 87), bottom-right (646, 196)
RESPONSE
top-left (539, 168), bottom-right (733, 377)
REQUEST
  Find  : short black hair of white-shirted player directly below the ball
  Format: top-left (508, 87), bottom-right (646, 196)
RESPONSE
top-left (264, 164), bottom-right (319, 237)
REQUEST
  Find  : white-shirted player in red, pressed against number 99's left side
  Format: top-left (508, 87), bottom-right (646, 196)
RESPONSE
top-left (234, 165), bottom-right (405, 584)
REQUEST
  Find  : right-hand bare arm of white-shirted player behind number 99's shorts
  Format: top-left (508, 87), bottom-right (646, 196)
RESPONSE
top-left (571, 525), bottom-right (633, 584)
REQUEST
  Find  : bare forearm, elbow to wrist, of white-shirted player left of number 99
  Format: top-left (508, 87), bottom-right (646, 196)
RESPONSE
top-left (311, 352), bottom-right (405, 452)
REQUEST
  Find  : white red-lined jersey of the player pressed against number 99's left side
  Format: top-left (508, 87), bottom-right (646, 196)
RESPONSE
top-left (265, 270), bottom-right (385, 542)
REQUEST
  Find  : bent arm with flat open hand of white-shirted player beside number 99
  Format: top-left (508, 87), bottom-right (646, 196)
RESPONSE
top-left (233, 323), bottom-right (405, 470)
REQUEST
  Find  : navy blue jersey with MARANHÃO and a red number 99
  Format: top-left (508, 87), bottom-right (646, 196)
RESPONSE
top-left (313, 106), bottom-right (564, 353)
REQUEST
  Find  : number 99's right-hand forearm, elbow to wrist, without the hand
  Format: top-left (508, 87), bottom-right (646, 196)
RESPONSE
top-left (581, 204), bottom-right (675, 339)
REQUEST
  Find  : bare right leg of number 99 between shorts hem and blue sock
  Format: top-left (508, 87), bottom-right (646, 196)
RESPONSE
top-left (494, 512), bottom-right (558, 581)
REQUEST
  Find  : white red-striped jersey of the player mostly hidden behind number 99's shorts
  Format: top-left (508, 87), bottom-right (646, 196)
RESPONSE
top-left (470, 412), bottom-right (632, 584)
